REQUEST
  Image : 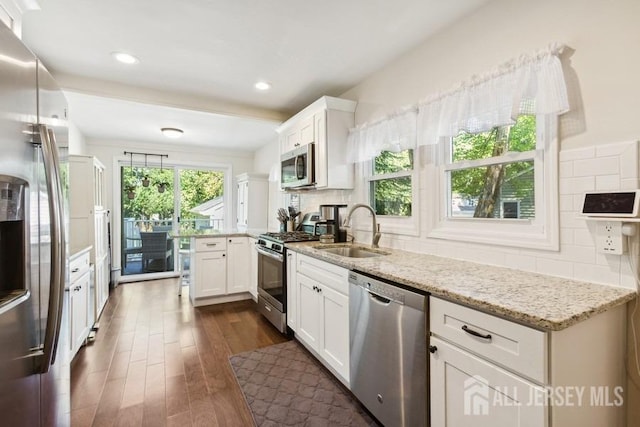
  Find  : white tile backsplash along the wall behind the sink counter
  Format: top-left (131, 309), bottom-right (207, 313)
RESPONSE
top-left (300, 141), bottom-right (640, 288)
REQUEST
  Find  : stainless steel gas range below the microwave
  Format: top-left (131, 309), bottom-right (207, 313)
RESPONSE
top-left (256, 231), bottom-right (318, 333)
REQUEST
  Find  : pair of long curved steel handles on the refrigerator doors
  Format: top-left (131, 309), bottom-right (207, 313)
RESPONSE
top-left (37, 125), bottom-right (65, 373)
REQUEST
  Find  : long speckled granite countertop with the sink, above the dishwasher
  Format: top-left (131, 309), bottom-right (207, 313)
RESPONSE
top-left (286, 242), bottom-right (636, 331)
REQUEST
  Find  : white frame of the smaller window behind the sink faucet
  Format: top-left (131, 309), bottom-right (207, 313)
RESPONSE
top-left (364, 148), bottom-right (420, 236)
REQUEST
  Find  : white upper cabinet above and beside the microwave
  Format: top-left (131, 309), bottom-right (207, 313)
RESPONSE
top-left (277, 96), bottom-right (357, 189)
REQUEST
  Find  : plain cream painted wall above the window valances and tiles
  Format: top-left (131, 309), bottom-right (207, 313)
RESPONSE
top-left (342, 0), bottom-right (640, 149)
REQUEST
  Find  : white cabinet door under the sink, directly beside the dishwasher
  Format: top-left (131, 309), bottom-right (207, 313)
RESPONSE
top-left (319, 286), bottom-right (349, 383)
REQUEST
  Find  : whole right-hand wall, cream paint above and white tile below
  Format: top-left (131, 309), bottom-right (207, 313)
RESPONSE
top-left (292, 0), bottom-right (640, 287)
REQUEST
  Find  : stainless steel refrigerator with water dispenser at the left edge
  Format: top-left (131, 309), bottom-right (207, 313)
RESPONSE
top-left (0, 23), bottom-right (70, 427)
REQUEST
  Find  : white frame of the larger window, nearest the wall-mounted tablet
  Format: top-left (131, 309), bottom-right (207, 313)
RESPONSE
top-left (427, 116), bottom-right (560, 251)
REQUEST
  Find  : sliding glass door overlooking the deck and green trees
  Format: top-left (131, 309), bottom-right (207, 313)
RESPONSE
top-left (120, 161), bottom-right (226, 280)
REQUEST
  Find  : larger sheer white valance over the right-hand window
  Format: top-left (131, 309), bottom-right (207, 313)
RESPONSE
top-left (418, 44), bottom-right (569, 145)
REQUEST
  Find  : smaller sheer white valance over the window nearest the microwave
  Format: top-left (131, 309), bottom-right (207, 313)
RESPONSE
top-left (347, 107), bottom-right (418, 163)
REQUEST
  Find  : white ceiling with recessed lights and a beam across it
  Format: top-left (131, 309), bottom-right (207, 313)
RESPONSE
top-left (22, 0), bottom-right (488, 150)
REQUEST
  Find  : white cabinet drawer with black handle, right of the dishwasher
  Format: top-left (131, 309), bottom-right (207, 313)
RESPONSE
top-left (429, 297), bottom-right (547, 383)
